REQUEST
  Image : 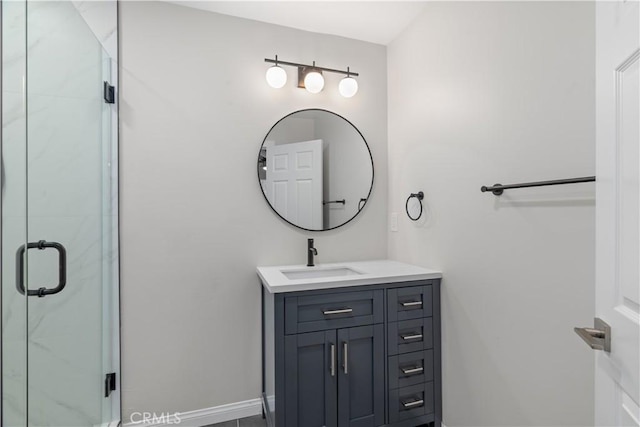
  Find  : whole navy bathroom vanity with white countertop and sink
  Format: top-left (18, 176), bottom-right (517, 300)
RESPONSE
top-left (258, 260), bottom-right (442, 427)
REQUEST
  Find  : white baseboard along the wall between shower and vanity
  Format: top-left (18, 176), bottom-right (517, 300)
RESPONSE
top-left (124, 399), bottom-right (262, 427)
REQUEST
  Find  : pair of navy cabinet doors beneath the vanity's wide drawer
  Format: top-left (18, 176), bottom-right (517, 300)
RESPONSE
top-left (284, 324), bottom-right (384, 427)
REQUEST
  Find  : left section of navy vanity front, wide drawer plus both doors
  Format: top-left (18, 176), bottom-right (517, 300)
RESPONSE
top-left (276, 289), bottom-right (385, 427)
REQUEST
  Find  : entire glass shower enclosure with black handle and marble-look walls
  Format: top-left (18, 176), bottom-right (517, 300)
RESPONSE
top-left (0, 0), bottom-right (120, 427)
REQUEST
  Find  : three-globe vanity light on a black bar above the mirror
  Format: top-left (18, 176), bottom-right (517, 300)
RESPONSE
top-left (264, 55), bottom-right (359, 98)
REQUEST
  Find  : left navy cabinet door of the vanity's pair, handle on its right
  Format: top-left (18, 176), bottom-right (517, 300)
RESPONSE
top-left (286, 330), bottom-right (338, 427)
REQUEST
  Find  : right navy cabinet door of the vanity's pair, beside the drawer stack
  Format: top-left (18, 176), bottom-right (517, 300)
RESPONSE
top-left (338, 324), bottom-right (385, 427)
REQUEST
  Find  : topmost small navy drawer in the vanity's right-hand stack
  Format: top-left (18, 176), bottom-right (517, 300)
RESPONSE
top-left (387, 285), bottom-right (433, 322)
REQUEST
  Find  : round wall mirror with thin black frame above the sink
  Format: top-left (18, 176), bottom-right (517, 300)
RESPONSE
top-left (258, 109), bottom-right (373, 231)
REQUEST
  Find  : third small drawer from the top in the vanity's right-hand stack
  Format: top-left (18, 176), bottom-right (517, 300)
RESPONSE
top-left (389, 350), bottom-right (433, 389)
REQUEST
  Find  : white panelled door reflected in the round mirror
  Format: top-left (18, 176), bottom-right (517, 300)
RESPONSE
top-left (265, 139), bottom-right (323, 230)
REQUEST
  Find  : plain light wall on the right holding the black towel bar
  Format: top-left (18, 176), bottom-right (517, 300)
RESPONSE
top-left (388, 2), bottom-right (595, 427)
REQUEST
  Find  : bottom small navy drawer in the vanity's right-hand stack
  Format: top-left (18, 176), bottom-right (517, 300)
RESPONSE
top-left (389, 382), bottom-right (435, 424)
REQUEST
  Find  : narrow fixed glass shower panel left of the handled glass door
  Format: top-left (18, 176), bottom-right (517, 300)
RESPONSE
top-left (0, 2), bottom-right (27, 426)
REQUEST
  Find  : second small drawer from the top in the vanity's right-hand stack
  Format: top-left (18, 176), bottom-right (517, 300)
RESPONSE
top-left (388, 317), bottom-right (433, 355)
